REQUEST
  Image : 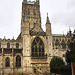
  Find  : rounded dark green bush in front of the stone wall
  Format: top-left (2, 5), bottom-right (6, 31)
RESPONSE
top-left (50, 56), bottom-right (65, 75)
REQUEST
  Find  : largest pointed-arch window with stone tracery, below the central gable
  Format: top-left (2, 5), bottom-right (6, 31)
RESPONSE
top-left (32, 37), bottom-right (44, 57)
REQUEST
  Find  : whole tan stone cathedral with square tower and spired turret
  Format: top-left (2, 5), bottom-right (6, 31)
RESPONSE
top-left (0, 0), bottom-right (71, 75)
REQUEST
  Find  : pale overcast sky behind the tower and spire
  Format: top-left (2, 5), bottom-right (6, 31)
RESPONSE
top-left (0, 0), bottom-right (75, 39)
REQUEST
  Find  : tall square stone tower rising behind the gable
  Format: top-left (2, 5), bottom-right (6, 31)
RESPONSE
top-left (21, 0), bottom-right (41, 37)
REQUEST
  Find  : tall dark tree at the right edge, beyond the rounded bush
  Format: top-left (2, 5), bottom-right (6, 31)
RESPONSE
top-left (65, 30), bottom-right (75, 65)
